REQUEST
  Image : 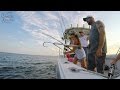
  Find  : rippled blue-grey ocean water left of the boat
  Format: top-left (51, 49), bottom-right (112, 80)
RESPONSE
top-left (0, 52), bottom-right (58, 79)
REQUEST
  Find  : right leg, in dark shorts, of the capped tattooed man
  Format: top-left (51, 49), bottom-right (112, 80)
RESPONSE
top-left (96, 53), bottom-right (106, 74)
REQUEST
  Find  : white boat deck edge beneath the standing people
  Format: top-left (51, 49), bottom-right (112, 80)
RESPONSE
top-left (58, 57), bottom-right (120, 79)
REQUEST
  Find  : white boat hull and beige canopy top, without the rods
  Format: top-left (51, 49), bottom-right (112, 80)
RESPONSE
top-left (56, 27), bottom-right (120, 79)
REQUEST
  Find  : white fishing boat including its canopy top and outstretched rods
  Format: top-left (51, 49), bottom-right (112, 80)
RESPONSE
top-left (43, 25), bottom-right (120, 79)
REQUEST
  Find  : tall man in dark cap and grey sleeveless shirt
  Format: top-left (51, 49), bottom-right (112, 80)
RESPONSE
top-left (83, 16), bottom-right (107, 74)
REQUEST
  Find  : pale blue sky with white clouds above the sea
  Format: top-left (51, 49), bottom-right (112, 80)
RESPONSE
top-left (0, 11), bottom-right (120, 56)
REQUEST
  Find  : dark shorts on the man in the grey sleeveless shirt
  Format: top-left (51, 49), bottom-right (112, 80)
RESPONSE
top-left (88, 53), bottom-right (106, 74)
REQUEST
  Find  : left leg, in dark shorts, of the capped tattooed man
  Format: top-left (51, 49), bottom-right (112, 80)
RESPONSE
top-left (87, 53), bottom-right (96, 71)
